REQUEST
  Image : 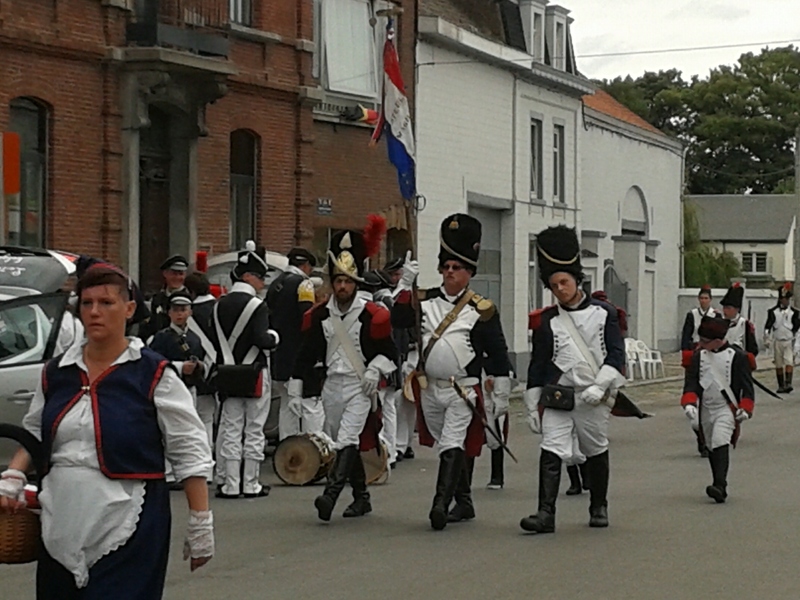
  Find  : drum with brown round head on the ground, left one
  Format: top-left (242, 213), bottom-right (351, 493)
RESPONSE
top-left (272, 433), bottom-right (336, 485)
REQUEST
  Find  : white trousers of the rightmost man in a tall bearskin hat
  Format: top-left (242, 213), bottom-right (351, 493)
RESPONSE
top-left (541, 399), bottom-right (611, 465)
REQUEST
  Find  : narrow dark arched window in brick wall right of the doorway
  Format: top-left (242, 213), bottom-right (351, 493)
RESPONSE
top-left (230, 129), bottom-right (258, 249)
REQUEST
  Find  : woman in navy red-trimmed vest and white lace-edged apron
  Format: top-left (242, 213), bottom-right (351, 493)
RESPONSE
top-left (0, 266), bottom-right (214, 600)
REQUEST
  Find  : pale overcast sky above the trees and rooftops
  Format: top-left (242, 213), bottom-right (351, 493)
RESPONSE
top-left (564, 0), bottom-right (800, 79)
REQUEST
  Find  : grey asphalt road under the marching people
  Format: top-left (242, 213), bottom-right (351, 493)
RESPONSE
top-left (0, 374), bottom-right (800, 600)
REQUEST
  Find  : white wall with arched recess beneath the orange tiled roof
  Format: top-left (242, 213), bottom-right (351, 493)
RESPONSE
top-left (579, 119), bottom-right (682, 351)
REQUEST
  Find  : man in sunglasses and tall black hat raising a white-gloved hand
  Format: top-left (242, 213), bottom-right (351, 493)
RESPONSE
top-left (392, 214), bottom-right (511, 530)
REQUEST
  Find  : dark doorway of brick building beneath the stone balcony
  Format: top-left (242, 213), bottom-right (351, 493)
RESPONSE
top-left (139, 106), bottom-right (171, 294)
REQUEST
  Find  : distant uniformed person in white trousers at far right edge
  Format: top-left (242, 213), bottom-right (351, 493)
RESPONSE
top-left (764, 283), bottom-right (800, 394)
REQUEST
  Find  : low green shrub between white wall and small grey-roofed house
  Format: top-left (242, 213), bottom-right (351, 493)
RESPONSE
top-left (683, 200), bottom-right (742, 288)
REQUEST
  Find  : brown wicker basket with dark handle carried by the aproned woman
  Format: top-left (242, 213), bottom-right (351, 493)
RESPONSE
top-left (0, 423), bottom-right (44, 564)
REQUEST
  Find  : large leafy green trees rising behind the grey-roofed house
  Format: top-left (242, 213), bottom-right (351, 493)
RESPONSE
top-left (600, 46), bottom-right (800, 194)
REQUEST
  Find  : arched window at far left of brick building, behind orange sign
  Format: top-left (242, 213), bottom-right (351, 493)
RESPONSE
top-left (8, 98), bottom-right (49, 247)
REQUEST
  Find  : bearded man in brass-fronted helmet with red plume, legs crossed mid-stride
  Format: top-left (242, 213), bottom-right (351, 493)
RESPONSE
top-left (287, 219), bottom-right (397, 521)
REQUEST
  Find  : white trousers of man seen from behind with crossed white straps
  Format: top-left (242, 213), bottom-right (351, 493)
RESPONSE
top-left (218, 373), bottom-right (271, 495)
